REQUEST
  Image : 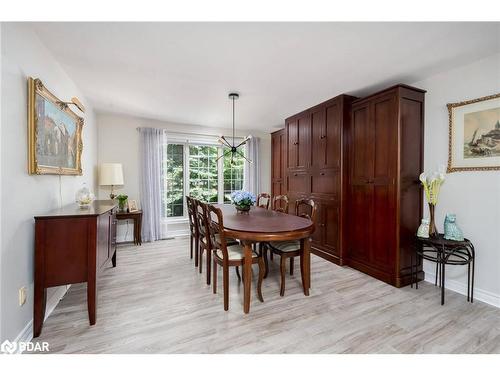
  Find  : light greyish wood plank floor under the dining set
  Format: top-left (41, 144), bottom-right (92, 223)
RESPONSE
top-left (35, 238), bottom-right (500, 353)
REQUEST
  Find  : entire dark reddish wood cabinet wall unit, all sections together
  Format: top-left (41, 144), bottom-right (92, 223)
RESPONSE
top-left (272, 85), bottom-right (425, 287)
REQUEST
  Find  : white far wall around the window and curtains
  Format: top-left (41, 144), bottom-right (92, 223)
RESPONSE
top-left (97, 113), bottom-right (271, 242)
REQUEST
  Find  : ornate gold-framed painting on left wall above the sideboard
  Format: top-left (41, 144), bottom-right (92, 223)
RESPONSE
top-left (28, 77), bottom-right (83, 175)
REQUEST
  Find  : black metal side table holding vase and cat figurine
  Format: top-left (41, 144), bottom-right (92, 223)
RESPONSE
top-left (411, 234), bottom-right (475, 305)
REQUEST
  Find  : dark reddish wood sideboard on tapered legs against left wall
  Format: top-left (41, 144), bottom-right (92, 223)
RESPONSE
top-left (33, 201), bottom-right (116, 337)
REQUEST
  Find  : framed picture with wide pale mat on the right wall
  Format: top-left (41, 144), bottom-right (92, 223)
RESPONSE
top-left (447, 94), bottom-right (500, 173)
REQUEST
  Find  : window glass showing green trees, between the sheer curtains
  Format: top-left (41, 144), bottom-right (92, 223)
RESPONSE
top-left (162, 142), bottom-right (245, 219)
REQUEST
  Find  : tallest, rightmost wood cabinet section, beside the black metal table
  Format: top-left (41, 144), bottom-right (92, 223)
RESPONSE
top-left (347, 85), bottom-right (425, 286)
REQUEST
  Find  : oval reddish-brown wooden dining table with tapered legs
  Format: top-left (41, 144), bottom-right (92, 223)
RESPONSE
top-left (215, 204), bottom-right (314, 314)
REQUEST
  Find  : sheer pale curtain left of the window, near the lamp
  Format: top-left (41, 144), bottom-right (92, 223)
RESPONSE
top-left (138, 128), bottom-right (166, 242)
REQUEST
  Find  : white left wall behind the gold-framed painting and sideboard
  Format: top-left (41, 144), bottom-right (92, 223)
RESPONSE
top-left (0, 23), bottom-right (97, 341)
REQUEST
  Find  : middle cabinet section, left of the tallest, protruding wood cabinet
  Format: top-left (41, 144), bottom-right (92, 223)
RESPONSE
top-left (285, 95), bottom-right (355, 264)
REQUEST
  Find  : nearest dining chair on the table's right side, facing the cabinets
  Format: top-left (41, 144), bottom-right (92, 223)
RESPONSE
top-left (262, 198), bottom-right (317, 297)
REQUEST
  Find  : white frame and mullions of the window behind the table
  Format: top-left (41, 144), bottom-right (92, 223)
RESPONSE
top-left (162, 133), bottom-right (247, 224)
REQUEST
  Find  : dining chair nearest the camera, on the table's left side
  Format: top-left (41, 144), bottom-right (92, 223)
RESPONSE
top-left (207, 205), bottom-right (264, 311)
